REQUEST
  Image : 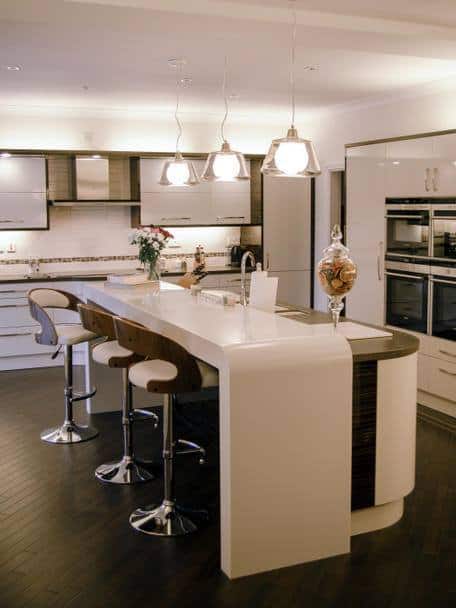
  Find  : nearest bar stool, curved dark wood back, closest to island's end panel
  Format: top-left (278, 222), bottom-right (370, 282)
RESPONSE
top-left (114, 317), bottom-right (218, 536)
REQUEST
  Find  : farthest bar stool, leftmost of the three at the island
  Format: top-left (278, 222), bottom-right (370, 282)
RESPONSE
top-left (28, 288), bottom-right (98, 444)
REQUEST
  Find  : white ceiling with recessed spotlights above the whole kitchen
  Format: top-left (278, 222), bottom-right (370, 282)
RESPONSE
top-left (0, 0), bottom-right (456, 122)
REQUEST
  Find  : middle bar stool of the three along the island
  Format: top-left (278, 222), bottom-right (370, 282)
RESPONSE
top-left (78, 304), bottom-right (158, 484)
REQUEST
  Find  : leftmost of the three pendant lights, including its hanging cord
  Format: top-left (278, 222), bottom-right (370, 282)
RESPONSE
top-left (158, 59), bottom-right (200, 186)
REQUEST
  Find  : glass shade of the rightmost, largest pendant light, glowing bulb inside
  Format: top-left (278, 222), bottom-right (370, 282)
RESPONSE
top-left (261, 127), bottom-right (321, 177)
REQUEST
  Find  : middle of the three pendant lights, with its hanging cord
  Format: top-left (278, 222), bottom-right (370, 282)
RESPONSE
top-left (201, 57), bottom-right (250, 182)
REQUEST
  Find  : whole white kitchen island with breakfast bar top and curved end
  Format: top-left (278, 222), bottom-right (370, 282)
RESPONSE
top-left (84, 282), bottom-right (419, 578)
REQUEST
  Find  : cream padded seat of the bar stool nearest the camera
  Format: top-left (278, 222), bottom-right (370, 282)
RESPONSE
top-left (128, 359), bottom-right (218, 390)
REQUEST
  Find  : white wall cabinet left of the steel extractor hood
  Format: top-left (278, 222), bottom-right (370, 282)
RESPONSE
top-left (0, 156), bottom-right (48, 230)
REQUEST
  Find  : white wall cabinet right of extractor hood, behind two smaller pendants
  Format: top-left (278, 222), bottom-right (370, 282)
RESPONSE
top-left (140, 158), bottom-right (250, 226)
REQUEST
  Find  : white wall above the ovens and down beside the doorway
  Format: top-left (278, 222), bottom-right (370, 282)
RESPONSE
top-left (307, 83), bottom-right (456, 310)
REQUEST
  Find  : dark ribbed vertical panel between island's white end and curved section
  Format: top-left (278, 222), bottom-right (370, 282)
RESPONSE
top-left (352, 361), bottom-right (377, 511)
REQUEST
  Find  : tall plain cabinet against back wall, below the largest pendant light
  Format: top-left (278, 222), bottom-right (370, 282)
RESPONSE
top-left (263, 176), bottom-right (311, 306)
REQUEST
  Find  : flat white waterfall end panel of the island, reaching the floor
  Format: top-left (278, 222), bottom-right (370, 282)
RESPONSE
top-left (220, 336), bottom-right (353, 578)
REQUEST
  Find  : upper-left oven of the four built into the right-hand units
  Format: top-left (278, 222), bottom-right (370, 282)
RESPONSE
top-left (386, 200), bottom-right (430, 258)
